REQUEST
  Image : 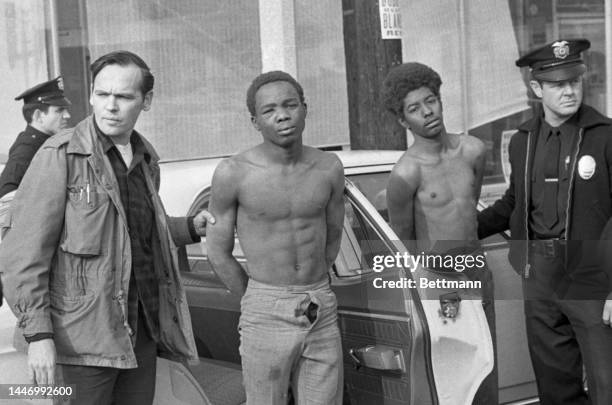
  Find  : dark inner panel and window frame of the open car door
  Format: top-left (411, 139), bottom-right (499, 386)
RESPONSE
top-left (338, 180), bottom-right (438, 405)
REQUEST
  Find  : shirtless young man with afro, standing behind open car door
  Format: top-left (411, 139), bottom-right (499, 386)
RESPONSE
top-left (384, 63), bottom-right (498, 404)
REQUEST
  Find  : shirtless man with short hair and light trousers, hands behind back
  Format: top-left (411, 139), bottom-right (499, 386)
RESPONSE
top-left (207, 71), bottom-right (344, 405)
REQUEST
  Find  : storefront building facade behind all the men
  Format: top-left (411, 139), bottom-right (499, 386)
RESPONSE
top-left (0, 0), bottom-right (612, 183)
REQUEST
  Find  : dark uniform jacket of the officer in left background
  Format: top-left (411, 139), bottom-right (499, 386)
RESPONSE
top-left (0, 125), bottom-right (49, 197)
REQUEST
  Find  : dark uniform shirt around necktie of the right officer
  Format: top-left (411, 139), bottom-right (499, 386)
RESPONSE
top-left (529, 115), bottom-right (578, 239)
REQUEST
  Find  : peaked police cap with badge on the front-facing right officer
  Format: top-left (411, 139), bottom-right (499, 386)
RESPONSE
top-left (516, 39), bottom-right (591, 82)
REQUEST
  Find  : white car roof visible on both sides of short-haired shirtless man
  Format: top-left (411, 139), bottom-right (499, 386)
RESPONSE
top-left (159, 150), bottom-right (404, 216)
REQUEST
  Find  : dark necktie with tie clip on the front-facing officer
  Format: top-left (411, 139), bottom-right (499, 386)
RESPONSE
top-left (542, 129), bottom-right (561, 228)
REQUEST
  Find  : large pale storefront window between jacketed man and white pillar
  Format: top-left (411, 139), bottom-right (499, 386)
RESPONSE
top-left (86, 0), bottom-right (261, 159)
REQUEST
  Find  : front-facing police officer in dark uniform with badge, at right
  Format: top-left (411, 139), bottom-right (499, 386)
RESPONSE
top-left (478, 39), bottom-right (612, 405)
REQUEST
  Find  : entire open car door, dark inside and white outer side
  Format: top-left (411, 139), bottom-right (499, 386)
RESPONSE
top-left (332, 180), bottom-right (493, 405)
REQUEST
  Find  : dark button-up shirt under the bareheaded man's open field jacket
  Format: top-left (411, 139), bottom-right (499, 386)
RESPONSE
top-left (96, 122), bottom-right (159, 341)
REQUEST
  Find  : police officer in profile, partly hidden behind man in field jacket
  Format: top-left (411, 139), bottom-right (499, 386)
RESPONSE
top-left (0, 76), bottom-right (70, 197)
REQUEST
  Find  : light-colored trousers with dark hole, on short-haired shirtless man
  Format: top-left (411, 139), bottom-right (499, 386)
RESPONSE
top-left (239, 279), bottom-right (343, 405)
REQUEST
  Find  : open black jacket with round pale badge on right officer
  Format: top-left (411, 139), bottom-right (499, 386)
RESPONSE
top-left (478, 104), bottom-right (612, 299)
